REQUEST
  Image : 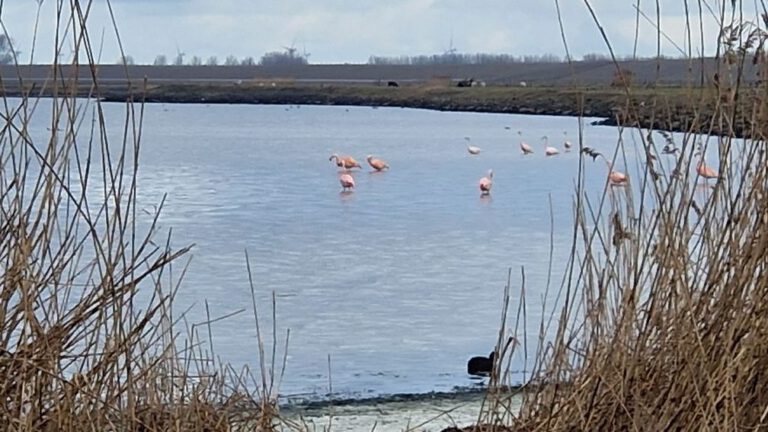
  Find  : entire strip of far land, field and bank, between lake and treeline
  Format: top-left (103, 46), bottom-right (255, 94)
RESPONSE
top-left (0, 59), bottom-right (756, 136)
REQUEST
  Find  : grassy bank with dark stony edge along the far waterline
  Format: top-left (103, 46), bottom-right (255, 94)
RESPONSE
top-left (96, 82), bottom-right (768, 136)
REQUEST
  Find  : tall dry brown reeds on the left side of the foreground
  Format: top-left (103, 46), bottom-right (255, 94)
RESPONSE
top-left (0, 1), bottom-right (288, 431)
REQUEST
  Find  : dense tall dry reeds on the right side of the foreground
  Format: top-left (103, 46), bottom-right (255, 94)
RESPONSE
top-left (498, 1), bottom-right (768, 431)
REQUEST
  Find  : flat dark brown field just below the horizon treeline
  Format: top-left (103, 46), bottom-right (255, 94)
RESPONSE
top-left (0, 59), bottom-right (754, 86)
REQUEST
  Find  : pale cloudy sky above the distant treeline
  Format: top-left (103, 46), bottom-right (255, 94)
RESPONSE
top-left (0, 0), bottom-right (749, 63)
